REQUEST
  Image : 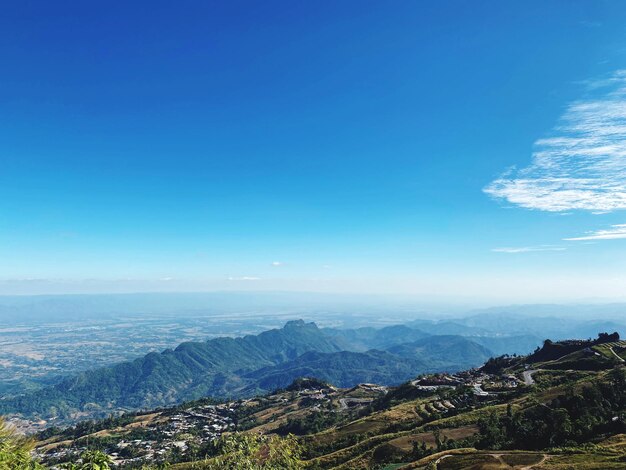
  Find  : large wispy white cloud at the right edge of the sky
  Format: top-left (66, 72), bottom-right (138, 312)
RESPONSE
top-left (484, 70), bottom-right (626, 212)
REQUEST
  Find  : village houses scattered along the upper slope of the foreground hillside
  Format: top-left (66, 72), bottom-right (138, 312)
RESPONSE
top-left (37, 369), bottom-right (523, 469)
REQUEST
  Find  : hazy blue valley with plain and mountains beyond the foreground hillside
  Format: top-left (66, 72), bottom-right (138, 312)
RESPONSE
top-left (0, 311), bottom-right (625, 432)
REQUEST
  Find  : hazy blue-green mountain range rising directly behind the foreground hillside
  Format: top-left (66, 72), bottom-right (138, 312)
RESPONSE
top-left (0, 314), bottom-right (615, 423)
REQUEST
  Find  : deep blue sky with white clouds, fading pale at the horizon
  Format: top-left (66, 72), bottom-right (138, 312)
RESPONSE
top-left (0, 1), bottom-right (626, 301)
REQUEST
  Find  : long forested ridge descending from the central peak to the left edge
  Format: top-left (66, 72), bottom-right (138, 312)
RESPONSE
top-left (0, 321), bottom-right (340, 416)
